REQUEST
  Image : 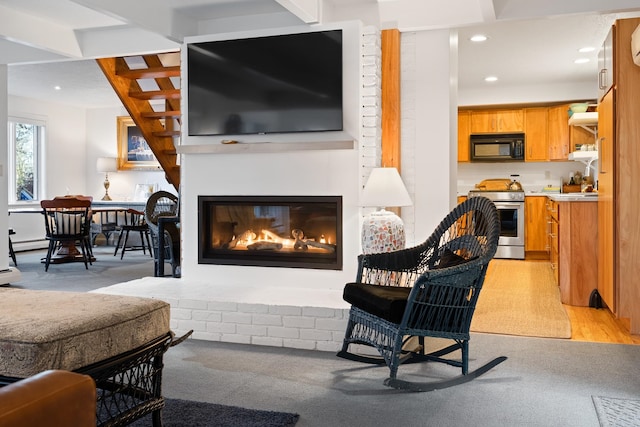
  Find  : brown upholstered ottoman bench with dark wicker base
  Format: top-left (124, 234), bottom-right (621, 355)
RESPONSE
top-left (0, 288), bottom-right (173, 426)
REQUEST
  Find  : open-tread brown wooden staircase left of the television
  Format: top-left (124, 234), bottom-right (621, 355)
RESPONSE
top-left (96, 52), bottom-right (181, 190)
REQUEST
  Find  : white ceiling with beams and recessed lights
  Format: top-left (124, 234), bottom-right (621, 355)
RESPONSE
top-left (0, 0), bottom-right (640, 108)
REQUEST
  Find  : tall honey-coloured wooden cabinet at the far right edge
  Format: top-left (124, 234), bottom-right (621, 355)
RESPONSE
top-left (598, 18), bottom-right (640, 334)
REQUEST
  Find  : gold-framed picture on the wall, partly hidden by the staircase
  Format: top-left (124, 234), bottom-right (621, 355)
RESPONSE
top-left (118, 116), bottom-right (160, 170)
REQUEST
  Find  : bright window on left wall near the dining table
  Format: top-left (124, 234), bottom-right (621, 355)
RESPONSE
top-left (7, 118), bottom-right (45, 203)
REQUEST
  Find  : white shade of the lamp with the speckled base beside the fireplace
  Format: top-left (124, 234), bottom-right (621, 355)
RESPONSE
top-left (360, 168), bottom-right (412, 208)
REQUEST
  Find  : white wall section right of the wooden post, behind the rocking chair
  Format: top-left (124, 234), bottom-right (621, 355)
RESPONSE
top-left (401, 30), bottom-right (457, 245)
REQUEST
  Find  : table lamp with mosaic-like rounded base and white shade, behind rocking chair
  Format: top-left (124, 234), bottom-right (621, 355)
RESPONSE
top-left (360, 168), bottom-right (412, 254)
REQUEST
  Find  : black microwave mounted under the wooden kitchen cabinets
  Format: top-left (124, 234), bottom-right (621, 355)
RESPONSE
top-left (469, 133), bottom-right (524, 162)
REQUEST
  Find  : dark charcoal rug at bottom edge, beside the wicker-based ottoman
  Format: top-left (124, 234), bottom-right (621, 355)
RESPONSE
top-left (129, 399), bottom-right (300, 427)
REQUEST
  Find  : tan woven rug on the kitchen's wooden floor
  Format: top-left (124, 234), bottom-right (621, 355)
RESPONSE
top-left (471, 259), bottom-right (571, 338)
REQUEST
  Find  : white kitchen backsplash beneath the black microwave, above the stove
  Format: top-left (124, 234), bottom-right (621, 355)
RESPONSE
top-left (458, 162), bottom-right (584, 195)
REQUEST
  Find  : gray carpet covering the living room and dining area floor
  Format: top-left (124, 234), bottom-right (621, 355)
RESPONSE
top-left (8, 244), bottom-right (640, 427)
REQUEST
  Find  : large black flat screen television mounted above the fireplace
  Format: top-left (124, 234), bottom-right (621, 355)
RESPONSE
top-left (187, 30), bottom-right (343, 136)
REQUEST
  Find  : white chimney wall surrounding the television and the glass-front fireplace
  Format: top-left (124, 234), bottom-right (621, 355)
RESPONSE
top-left (181, 23), bottom-right (362, 292)
